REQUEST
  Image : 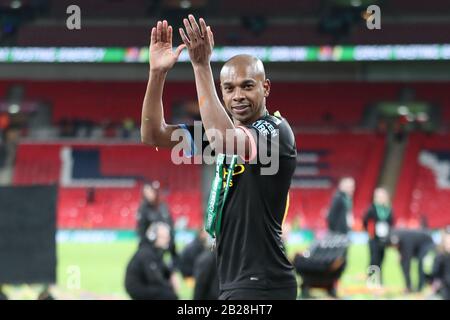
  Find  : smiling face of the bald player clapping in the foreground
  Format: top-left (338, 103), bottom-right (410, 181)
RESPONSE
top-left (220, 64), bottom-right (270, 124)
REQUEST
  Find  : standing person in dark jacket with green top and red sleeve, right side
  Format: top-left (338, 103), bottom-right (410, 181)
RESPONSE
top-left (363, 188), bottom-right (393, 280)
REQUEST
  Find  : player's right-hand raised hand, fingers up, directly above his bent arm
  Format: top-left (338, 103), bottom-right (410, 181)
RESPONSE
top-left (179, 14), bottom-right (214, 66)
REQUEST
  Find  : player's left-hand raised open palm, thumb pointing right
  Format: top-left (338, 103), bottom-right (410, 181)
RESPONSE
top-left (149, 20), bottom-right (185, 71)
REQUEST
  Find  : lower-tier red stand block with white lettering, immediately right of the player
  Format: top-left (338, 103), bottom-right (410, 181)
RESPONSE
top-left (288, 133), bottom-right (385, 229)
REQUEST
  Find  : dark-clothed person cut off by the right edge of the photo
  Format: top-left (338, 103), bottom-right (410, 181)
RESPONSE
top-left (432, 226), bottom-right (450, 300)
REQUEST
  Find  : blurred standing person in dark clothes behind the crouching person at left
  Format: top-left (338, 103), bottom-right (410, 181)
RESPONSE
top-left (137, 181), bottom-right (178, 266)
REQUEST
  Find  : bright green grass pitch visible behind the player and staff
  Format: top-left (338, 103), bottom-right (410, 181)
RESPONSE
top-left (48, 241), bottom-right (417, 299)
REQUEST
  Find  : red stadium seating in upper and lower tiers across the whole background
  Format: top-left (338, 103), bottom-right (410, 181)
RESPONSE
top-left (6, 81), bottom-right (450, 229)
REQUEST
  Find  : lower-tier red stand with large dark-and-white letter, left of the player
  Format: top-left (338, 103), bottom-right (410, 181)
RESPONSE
top-left (13, 143), bottom-right (202, 229)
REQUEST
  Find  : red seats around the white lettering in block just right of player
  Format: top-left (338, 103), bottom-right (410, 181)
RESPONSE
top-left (287, 134), bottom-right (384, 229)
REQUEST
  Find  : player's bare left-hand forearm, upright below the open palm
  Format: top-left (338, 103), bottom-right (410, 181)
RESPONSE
top-left (141, 71), bottom-right (167, 144)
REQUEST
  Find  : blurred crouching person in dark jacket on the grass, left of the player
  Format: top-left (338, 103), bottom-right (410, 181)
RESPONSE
top-left (125, 222), bottom-right (177, 300)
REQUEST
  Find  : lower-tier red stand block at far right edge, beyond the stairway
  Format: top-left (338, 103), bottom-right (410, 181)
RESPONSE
top-left (394, 133), bottom-right (450, 228)
